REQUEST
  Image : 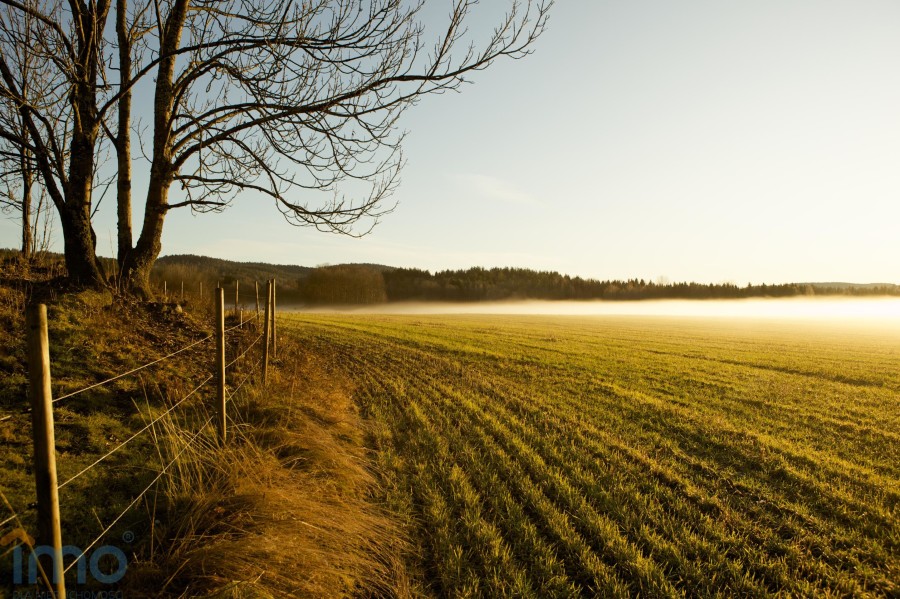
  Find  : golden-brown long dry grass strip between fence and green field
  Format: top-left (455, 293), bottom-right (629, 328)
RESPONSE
top-left (130, 340), bottom-right (412, 597)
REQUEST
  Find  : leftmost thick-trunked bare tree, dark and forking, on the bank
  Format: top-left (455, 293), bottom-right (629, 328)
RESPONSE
top-left (0, 0), bottom-right (110, 285)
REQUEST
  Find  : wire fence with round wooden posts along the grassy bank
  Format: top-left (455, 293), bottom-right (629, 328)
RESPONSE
top-left (0, 282), bottom-right (275, 596)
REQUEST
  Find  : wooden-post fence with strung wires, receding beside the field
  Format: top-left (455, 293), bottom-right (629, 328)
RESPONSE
top-left (14, 280), bottom-right (275, 597)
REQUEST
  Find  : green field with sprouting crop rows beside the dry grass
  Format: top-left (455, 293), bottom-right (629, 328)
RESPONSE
top-left (282, 315), bottom-right (900, 597)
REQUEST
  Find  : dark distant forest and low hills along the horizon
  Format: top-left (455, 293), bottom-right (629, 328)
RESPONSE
top-left (153, 256), bottom-right (900, 305)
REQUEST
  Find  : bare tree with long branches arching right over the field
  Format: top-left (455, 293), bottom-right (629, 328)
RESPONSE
top-left (118, 0), bottom-right (550, 290)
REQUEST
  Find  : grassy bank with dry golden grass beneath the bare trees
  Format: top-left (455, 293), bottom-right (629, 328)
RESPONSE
top-left (0, 270), bottom-right (407, 597)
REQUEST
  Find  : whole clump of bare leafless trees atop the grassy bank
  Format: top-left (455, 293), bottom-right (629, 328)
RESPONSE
top-left (0, 0), bottom-right (551, 294)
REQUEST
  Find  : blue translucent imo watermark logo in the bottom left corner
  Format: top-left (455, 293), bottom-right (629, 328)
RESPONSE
top-left (0, 529), bottom-right (128, 584)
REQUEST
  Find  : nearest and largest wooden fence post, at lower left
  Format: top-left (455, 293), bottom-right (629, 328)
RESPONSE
top-left (25, 304), bottom-right (66, 598)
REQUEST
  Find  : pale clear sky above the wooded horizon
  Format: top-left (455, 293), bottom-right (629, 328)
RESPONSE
top-left (0, 0), bottom-right (900, 285)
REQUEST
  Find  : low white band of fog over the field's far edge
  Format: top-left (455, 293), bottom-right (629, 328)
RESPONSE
top-left (279, 298), bottom-right (900, 327)
